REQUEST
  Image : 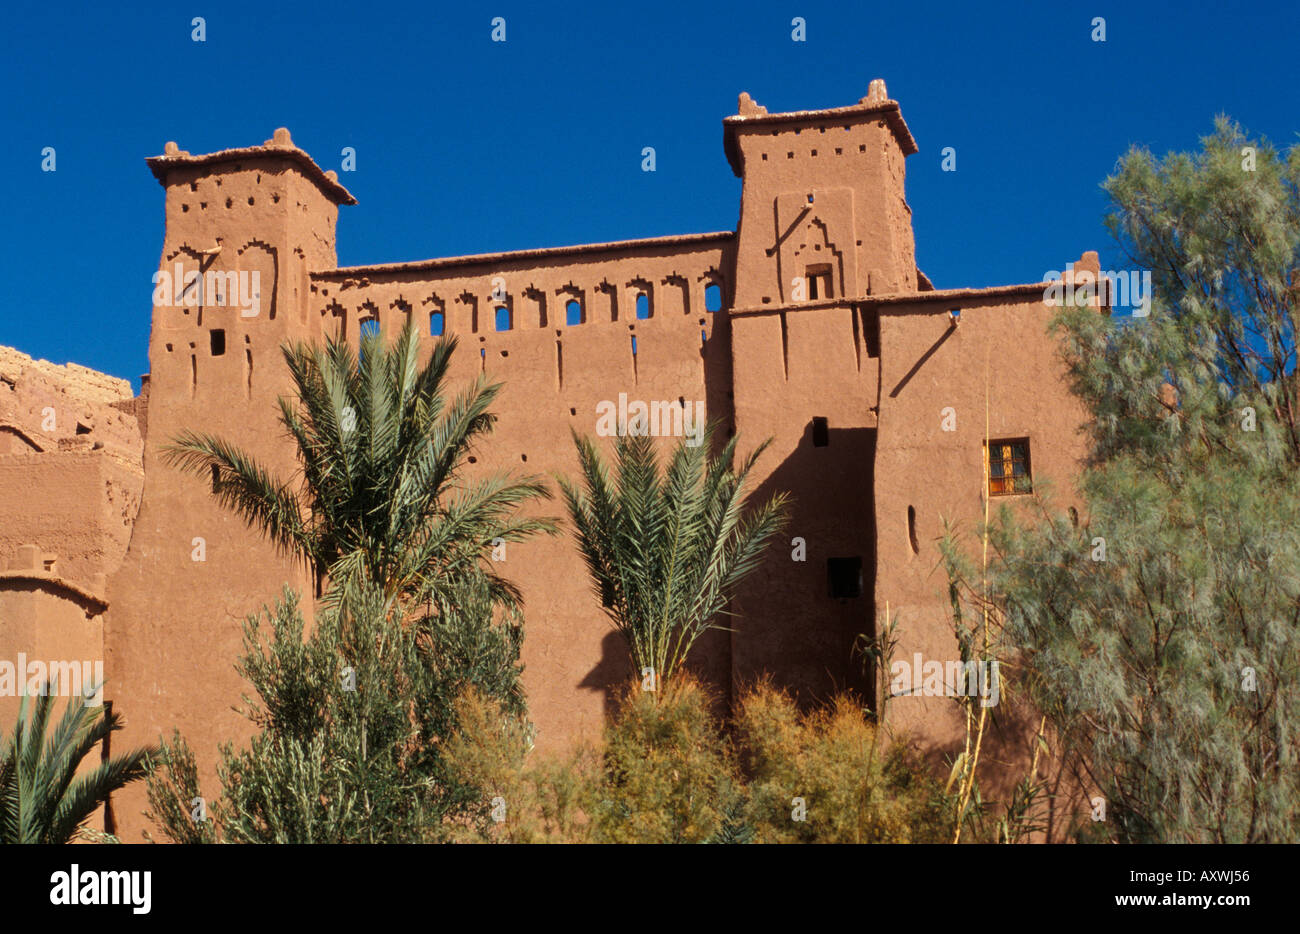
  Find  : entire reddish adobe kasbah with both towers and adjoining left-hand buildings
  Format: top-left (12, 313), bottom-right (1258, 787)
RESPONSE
top-left (0, 81), bottom-right (1105, 842)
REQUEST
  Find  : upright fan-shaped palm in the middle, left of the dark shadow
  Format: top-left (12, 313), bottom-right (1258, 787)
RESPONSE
top-left (559, 425), bottom-right (788, 683)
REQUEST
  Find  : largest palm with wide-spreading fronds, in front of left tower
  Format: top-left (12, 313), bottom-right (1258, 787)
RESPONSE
top-left (165, 324), bottom-right (555, 606)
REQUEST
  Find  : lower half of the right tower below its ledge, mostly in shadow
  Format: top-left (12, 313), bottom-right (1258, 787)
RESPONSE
top-left (732, 302), bottom-right (879, 699)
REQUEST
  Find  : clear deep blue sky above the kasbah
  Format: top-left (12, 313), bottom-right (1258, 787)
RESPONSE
top-left (0, 0), bottom-right (1300, 385)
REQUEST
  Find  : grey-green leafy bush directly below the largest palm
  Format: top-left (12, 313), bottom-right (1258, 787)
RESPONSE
top-left (151, 580), bottom-right (524, 843)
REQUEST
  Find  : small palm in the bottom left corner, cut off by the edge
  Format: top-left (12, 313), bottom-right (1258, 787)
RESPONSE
top-left (0, 687), bottom-right (156, 843)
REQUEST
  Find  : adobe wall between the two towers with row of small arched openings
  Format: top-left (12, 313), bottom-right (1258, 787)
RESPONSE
top-left (312, 233), bottom-right (733, 751)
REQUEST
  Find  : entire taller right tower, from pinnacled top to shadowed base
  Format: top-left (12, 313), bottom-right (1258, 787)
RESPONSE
top-left (723, 81), bottom-right (919, 700)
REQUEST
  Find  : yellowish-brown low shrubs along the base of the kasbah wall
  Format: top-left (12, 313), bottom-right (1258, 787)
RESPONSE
top-left (446, 678), bottom-right (952, 844)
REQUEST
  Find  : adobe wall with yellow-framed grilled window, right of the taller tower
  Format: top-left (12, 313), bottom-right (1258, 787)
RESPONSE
top-left (875, 278), bottom-right (1096, 795)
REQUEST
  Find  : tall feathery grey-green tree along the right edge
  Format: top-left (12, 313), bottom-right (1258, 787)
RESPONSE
top-left (950, 120), bottom-right (1300, 843)
